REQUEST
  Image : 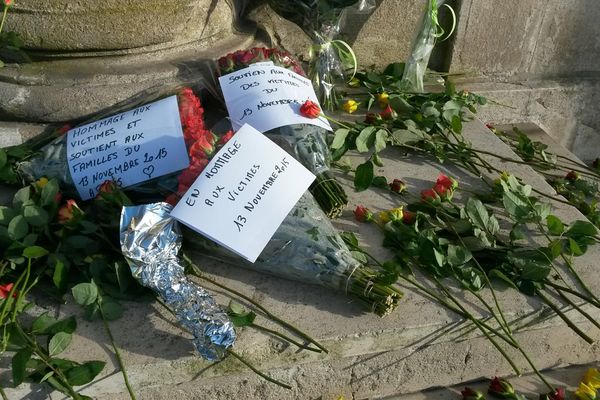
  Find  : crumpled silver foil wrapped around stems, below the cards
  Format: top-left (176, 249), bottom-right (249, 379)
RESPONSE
top-left (121, 203), bottom-right (236, 361)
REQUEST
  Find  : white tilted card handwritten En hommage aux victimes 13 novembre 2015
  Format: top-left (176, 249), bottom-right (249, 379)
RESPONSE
top-left (171, 125), bottom-right (315, 262)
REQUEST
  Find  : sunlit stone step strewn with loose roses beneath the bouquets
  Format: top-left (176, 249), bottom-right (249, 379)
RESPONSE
top-left (0, 119), bottom-right (600, 400)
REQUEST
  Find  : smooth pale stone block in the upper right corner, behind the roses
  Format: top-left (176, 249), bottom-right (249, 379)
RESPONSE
top-left (450, 0), bottom-right (600, 80)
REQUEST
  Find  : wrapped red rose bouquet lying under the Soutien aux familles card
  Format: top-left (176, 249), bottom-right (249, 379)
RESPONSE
top-left (218, 48), bottom-right (348, 218)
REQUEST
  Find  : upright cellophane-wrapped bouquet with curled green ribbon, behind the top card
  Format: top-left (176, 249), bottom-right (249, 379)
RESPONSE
top-left (268, 0), bottom-right (375, 111)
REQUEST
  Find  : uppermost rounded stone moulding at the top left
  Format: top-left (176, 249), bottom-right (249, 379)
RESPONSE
top-left (6, 0), bottom-right (232, 55)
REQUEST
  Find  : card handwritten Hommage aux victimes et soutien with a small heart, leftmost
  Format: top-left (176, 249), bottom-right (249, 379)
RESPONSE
top-left (67, 96), bottom-right (189, 200)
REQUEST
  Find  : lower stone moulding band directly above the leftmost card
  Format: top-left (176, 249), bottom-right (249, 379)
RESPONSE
top-left (0, 35), bottom-right (257, 123)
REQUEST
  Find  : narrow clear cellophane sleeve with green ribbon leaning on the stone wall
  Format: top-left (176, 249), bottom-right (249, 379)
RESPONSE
top-left (400, 0), bottom-right (456, 93)
